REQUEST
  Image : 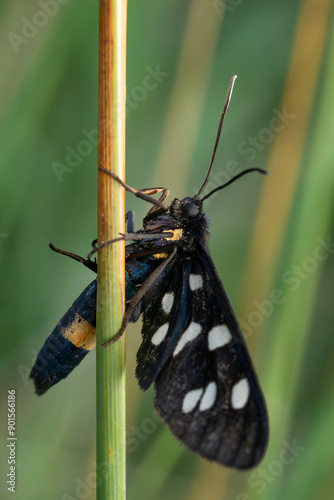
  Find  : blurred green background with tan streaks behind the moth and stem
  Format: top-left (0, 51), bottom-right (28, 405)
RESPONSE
top-left (0, 0), bottom-right (334, 500)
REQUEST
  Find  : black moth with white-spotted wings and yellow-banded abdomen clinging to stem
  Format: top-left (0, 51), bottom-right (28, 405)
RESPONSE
top-left (31, 77), bottom-right (269, 469)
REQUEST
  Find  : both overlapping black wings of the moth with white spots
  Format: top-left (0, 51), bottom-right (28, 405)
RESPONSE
top-left (137, 243), bottom-right (268, 469)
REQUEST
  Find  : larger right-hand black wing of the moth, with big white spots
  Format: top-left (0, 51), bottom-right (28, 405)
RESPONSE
top-left (155, 245), bottom-right (268, 469)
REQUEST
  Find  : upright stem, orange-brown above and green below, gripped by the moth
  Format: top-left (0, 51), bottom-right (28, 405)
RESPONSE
top-left (96, 0), bottom-right (126, 500)
